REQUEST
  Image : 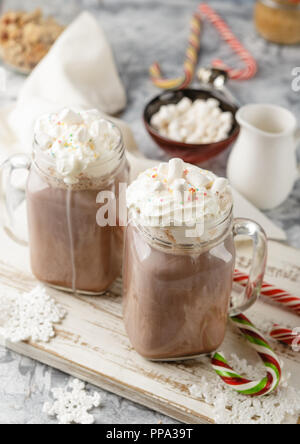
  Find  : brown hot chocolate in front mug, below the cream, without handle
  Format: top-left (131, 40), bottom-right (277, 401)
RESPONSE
top-left (124, 225), bottom-right (235, 359)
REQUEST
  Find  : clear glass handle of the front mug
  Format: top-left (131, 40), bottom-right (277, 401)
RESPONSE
top-left (230, 219), bottom-right (268, 316)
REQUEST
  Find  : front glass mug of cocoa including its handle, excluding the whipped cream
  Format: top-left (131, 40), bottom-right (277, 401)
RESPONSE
top-left (123, 212), bottom-right (267, 361)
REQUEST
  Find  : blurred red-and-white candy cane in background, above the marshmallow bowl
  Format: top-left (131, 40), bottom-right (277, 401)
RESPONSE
top-left (199, 3), bottom-right (258, 80)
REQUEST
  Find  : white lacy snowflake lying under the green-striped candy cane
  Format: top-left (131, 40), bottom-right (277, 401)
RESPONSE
top-left (190, 355), bottom-right (300, 424)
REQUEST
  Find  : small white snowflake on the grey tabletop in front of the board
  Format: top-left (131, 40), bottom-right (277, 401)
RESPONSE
top-left (43, 379), bottom-right (101, 424)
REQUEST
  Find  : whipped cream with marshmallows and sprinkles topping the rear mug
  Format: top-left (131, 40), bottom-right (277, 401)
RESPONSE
top-left (35, 109), bottom-right (121, 185)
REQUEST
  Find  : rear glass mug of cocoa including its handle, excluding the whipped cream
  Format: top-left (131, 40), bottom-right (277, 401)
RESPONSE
top-left (0, 128), bottom-right (129, 295)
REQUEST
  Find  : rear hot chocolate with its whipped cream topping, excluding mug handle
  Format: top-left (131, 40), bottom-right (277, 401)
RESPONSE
top-left (27, 110), bottom-right (128, 294)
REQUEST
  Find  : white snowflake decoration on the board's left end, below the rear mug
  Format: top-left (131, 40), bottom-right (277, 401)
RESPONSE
top-left (0, 285), bottom-right (66, 342)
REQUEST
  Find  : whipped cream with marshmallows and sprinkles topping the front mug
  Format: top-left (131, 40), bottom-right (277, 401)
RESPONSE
top-left (127, 159), bottom-right (232, 243)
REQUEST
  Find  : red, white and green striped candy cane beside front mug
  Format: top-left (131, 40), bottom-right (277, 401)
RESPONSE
top-left (212, 315), bottom-right (282, 396)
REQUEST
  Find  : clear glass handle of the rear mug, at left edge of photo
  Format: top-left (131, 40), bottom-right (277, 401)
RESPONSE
top-left (0, 154), bottom-right (31, 245)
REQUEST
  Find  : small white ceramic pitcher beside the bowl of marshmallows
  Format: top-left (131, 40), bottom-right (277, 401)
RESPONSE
top-left (227, 104), bottom-right (300, 210)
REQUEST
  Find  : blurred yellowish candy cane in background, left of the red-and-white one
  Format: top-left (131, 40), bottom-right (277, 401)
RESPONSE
top-left (150, 12), bottom-right (201, 89)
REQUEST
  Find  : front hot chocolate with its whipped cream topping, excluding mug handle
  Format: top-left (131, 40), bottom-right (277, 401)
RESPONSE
top-left (124, 159), bottom-right (235, 359)
